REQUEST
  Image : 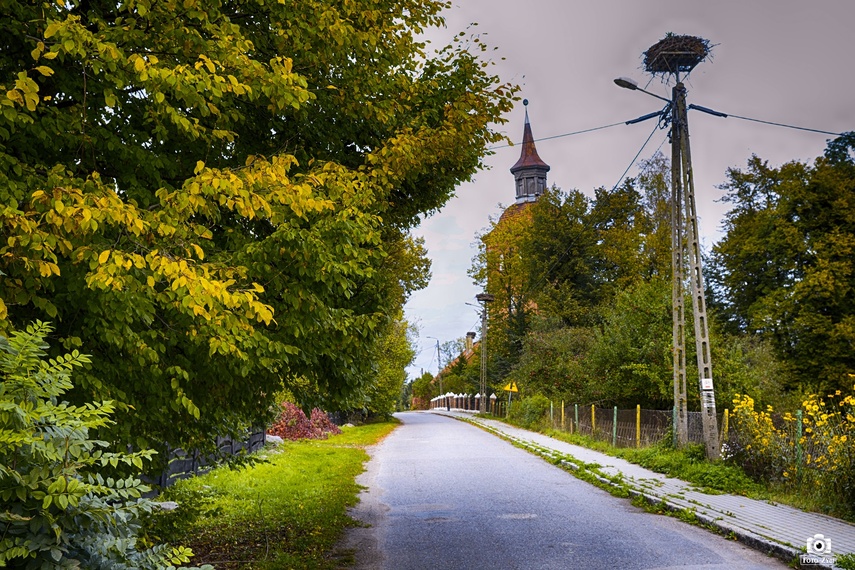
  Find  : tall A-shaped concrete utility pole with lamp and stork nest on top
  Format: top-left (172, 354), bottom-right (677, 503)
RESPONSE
top-left (615, 35), bottom-right (723, 459)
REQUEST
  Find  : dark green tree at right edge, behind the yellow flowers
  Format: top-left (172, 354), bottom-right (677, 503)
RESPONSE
top-left (711, 133), bottom-right (855, 393)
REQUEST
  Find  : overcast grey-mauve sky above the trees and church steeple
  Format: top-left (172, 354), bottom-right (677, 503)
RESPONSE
top-left (406, 0), bottom-right (855, 377)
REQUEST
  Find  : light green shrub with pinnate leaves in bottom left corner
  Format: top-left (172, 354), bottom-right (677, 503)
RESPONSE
top-left (0, 322), bottom-right (211, 570)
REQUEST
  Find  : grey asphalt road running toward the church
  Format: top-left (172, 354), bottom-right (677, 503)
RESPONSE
top-left (343, 412), bottom-right (786, 570)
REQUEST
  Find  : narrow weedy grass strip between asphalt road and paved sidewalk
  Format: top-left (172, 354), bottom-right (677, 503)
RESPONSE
top-left (455, 416), bottom-right (808, 569)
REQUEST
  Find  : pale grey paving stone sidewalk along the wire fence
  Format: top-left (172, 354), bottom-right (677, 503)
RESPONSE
top-left (435, 410), bottom-right (855, 568)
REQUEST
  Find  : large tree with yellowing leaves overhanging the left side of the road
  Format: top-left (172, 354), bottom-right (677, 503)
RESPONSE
top-left (0, 0), bottom-right (514, 447)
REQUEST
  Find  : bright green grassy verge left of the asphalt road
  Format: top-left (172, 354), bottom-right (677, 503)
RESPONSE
top-left (149, 421), bottom-right (397, 570)
